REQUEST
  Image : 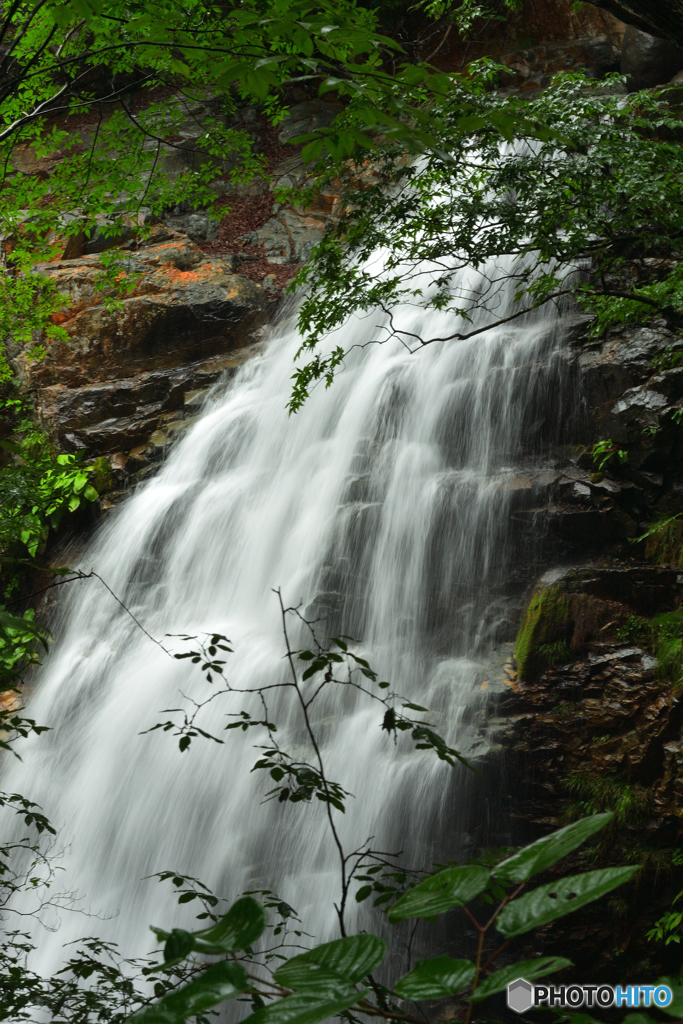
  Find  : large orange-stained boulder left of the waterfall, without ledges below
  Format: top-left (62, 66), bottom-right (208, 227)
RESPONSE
top-left (8, 228), bottom-right (272, 389)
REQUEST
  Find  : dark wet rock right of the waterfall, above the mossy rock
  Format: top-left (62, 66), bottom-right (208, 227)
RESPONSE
top-left (528, 322), bottom-right (683, 557)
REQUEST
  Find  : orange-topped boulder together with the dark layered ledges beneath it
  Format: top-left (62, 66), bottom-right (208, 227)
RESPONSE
top-left (10, 226), bottom-right (273, 477)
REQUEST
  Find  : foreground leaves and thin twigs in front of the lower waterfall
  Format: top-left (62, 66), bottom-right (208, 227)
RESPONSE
top-left (0, 598), bottom-right (638, 1024)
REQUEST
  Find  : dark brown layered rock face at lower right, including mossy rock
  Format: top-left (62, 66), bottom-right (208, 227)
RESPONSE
top-left (499, 565), bottom-right (683, 982)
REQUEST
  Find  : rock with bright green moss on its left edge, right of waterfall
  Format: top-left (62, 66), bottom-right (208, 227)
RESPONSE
top-left (515, 583), bottom-right (630, 682)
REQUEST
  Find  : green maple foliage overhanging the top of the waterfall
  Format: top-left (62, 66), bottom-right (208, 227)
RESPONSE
top-left (291, 68), bottom-right (683, 411)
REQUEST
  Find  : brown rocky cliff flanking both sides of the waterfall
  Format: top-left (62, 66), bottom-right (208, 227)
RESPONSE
top-left (10, 0), bottom-right (683, 980)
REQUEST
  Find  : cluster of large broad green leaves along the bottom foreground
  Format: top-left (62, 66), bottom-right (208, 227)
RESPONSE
top-left (118, 814), bottom-right (637, 1024)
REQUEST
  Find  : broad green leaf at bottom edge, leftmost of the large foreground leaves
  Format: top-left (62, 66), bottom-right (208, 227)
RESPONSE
top-left (130, 961), bottom-right (249, 1024)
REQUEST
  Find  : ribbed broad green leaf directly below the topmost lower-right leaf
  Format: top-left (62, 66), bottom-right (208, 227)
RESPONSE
top-left (496, 864), bottom-right (639, 938)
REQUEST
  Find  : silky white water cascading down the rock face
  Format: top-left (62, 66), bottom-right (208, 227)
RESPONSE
top-left (4, 245), bottom-right (556, 972)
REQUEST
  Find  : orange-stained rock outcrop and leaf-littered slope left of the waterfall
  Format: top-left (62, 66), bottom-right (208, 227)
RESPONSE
top-left (3, 98), bottom-right (337, 491)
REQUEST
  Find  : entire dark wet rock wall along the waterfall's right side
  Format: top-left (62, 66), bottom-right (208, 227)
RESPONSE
top-left (491, 322), bottom-right (683, 981)
